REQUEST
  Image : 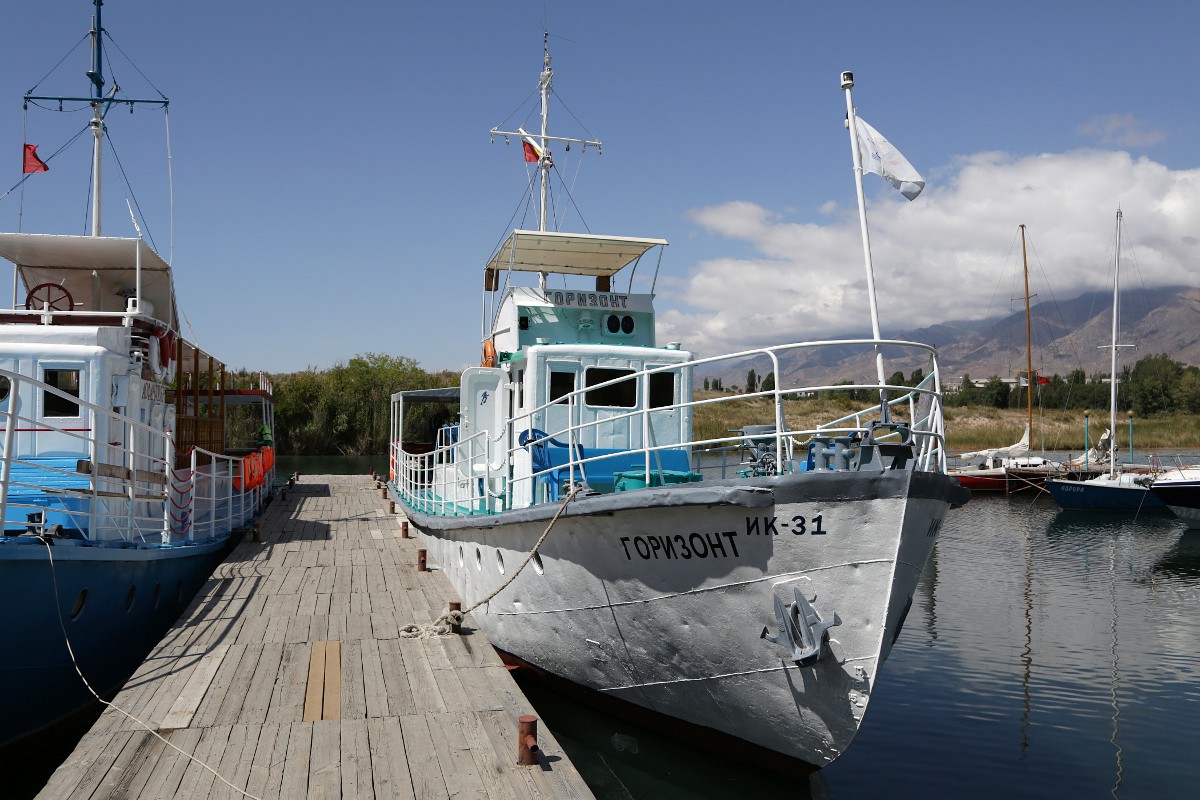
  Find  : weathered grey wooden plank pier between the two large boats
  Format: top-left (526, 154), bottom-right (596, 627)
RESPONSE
top-left (38, 475), bottom-right (592, 800)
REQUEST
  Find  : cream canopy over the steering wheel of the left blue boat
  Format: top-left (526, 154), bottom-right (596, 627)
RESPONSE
top-left (0, 234), bottom-right (179, 330)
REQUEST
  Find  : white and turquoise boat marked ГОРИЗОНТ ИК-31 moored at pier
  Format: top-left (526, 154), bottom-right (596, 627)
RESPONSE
top-left (389, 54), bottom-right (970, 765)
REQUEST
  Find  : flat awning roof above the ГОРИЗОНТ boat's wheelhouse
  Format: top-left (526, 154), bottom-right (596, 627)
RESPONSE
top-left (487, 230), bottom-right (667, 277)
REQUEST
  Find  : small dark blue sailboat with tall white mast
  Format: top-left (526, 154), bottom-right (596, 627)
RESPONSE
top-left (1046, 209), bottom-right (1165, 511)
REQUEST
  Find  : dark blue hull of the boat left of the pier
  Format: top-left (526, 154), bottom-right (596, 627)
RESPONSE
top-left (0, 536), bottom-right (229, 745)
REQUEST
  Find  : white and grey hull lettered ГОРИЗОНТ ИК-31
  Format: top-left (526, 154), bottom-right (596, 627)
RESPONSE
top-left (408, 470), bottom-right (968, 766)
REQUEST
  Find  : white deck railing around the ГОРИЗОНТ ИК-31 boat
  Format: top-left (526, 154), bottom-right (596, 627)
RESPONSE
top-left (390, 339), bottom-right (946, 516)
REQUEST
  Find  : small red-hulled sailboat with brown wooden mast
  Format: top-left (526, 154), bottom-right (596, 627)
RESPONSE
top-left (948, 224), bottom-right (1066, 493)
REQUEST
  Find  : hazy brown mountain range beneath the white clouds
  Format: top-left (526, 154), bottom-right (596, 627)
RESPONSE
top-left (701, 287), bottom-right (1200, 387)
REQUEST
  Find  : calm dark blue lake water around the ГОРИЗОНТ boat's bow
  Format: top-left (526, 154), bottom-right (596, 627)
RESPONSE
top-left (522, 495), bottom-right (1200, 800)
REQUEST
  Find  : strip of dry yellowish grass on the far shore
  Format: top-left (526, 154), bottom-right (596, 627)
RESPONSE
top-left (692, 391), bottom-right (1200, 452)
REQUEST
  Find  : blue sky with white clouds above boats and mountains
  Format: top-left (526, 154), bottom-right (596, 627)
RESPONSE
top-left (0, 0), bottom-right (1200, 372)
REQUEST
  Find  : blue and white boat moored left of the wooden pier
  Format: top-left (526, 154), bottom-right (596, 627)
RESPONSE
top-left (0, 0), bottom-right (274, 745)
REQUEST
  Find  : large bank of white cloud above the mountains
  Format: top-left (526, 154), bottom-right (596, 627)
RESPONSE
top-left (658, 150), bottom-right (1200, 354)
